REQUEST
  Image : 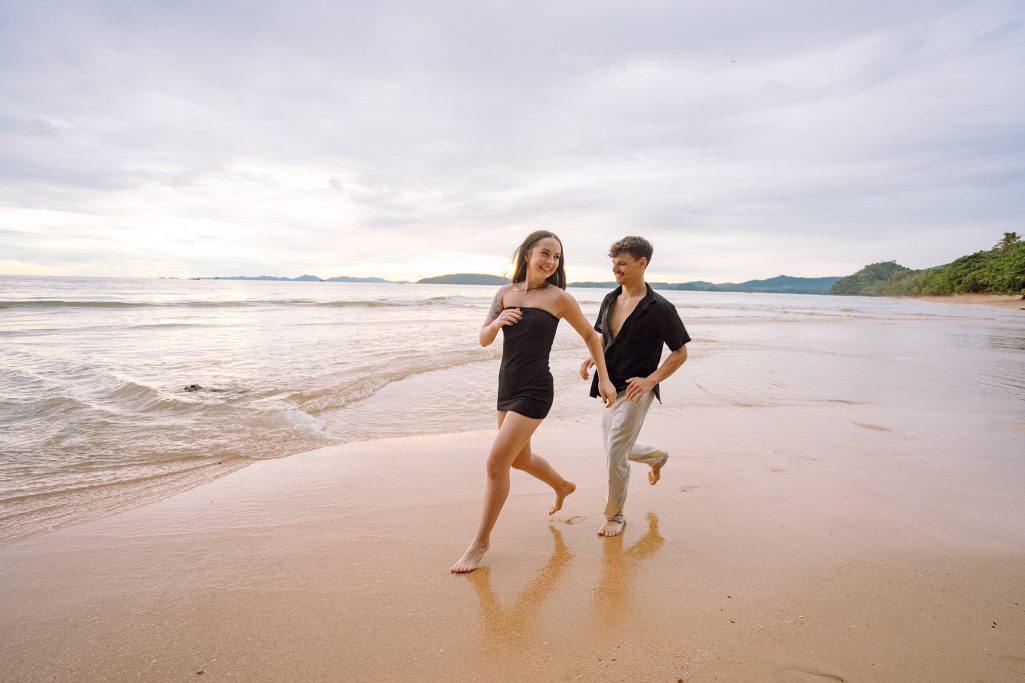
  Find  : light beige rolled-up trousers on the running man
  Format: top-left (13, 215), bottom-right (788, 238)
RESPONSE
top-left (602, 392), bottom-right (669, 522)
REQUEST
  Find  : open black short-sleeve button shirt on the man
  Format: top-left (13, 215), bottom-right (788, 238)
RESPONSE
top-left (590, 284), bottom-right (691, 402)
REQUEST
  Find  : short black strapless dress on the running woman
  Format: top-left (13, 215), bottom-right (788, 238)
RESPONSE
top-left (498, 306), bottom-right (559, 419)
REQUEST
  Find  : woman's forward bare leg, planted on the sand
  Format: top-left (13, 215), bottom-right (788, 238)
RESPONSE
top-left (452, 412), bottom-right (541, 573)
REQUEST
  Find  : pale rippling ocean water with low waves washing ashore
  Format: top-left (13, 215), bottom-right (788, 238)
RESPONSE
top-left (0, 277), bottom-right (1025, 539)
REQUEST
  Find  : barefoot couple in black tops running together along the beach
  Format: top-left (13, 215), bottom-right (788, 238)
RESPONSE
top-left (452, 230), bottom-right (691, 573)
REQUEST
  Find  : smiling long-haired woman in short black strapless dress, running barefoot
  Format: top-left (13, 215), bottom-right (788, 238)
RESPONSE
top-left (452, 230), bottom-right (616, 573)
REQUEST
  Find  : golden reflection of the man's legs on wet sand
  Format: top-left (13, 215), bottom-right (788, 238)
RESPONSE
top-left (595, 513), bottom-right (665, 625)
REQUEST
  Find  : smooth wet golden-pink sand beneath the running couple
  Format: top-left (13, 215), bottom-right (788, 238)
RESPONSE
top-left (0, 395), bottom-right (1025, 681)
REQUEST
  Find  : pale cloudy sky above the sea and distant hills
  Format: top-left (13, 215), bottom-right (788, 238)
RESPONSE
top-left (0, 0), bottom-right (1025, 282)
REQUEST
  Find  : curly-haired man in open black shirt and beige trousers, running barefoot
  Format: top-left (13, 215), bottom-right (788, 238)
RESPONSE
top-left (580, 237), bottom-right (691, 536)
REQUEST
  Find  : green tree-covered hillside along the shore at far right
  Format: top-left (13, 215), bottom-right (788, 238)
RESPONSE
top-left (829, 233), bottom-right (1025, 296)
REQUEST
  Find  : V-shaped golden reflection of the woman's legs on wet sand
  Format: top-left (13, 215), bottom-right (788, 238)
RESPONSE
top-left (466, 526), bottom-right (573, 648)
